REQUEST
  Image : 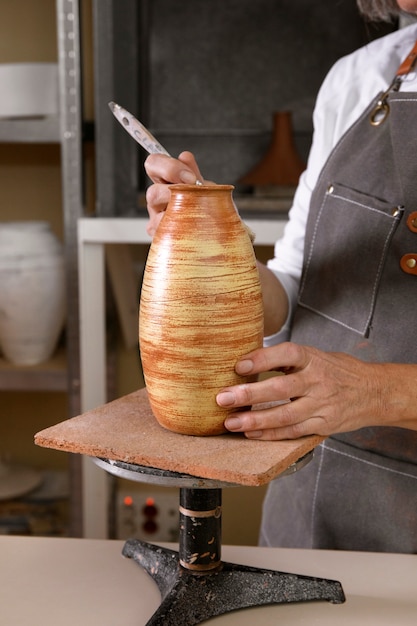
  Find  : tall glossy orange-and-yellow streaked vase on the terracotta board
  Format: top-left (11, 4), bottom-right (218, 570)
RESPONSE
top-left (139, 185), bottom-right (263, 435)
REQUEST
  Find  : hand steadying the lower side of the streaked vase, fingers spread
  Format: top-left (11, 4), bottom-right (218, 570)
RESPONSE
top-left (217, 342), bottom-right (383, 440)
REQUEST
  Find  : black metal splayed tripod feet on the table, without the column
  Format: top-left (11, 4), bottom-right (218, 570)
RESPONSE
top-left (123, 539), bottom-right (345, 626)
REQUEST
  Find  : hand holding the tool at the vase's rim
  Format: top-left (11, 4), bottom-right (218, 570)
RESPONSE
top-left (145, 152), bottom-right (205, 237)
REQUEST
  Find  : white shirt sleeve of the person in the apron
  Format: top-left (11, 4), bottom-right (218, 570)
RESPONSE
top-left (264, 23), bottom-right (417, 346)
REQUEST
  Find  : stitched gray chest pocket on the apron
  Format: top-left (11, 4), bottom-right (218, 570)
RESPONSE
top-left (299, 183), bottom-right (403, 336)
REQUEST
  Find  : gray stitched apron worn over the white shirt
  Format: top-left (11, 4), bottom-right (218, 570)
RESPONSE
top-left (260, 86), bottom-right (417, 553)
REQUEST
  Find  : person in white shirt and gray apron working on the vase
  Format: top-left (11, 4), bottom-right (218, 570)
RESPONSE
top-left (145, 0), bottom-right (417, 553)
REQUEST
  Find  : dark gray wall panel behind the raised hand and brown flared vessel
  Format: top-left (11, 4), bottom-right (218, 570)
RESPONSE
top-left (140, 0), bottom-right (393, 183)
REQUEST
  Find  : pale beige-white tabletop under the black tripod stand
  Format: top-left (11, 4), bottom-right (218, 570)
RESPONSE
top-left (0, 536), bottom-right (417, 626)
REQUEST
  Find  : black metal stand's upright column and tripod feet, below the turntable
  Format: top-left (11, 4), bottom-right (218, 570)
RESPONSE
top-left (123, 489), bottom-right (345, 626)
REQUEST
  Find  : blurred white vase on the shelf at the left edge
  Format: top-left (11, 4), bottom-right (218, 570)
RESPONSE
top-left (0, 222), bottom-right (66, 365)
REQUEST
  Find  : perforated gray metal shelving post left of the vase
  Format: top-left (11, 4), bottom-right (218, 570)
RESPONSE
top-left (56, 0), bottom-right (83, 536)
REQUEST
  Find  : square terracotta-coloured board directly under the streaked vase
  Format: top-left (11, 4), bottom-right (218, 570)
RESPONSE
top-left (35, 389), bottom-right (323, 486)
